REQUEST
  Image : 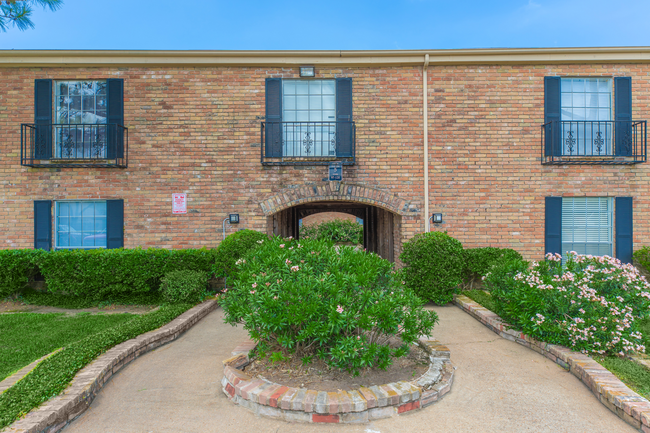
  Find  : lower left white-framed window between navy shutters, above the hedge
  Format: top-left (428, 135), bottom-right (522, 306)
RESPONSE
top-left (54, 201), bottom-right (106, 248)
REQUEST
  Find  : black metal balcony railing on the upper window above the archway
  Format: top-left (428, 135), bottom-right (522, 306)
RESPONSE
top-left (260, 121), bottom-right (356, 165)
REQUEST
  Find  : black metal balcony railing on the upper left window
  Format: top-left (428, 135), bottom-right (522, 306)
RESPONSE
top-left (20, 123), bottom-right (129, 168)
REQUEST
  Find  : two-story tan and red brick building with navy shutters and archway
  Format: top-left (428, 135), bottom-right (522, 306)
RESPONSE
top-left (0, 48), bottom-right (650, 260)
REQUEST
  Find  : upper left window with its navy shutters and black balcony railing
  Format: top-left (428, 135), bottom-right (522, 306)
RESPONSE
top-left (21, 78), bottom-right (128, 167)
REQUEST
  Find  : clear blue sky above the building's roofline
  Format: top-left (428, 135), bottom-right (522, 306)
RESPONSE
top-left (0, 0), bottom-right (650, 50)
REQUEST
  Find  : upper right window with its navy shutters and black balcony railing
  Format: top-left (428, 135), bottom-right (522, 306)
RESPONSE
top-left (542, 77), bottom-right (647, 164)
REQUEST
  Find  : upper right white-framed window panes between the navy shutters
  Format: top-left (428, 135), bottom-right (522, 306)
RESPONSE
top-left (561, 78), bottom-right (614, 156)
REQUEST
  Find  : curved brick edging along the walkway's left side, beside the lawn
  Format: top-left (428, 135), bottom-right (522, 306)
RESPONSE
top-left (2, 300), bottom-right (218, 433)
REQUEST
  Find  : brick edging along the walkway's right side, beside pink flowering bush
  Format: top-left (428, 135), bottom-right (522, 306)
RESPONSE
top-left (454, 295), bottom-right (650, 433)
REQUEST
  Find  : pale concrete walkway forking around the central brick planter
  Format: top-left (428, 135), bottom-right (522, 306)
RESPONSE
top-left (64, 306), bottom-right (636, 433)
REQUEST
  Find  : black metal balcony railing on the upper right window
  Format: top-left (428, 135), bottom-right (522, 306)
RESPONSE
top-left (541, 120), bottom-right (647, 164)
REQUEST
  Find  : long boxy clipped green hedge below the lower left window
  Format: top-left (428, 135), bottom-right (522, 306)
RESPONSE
top-left (36, 248), bottom-right (215, 300)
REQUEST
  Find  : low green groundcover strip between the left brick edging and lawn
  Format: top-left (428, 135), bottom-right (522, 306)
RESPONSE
top-left (0, 304), bottom-right (192, 429)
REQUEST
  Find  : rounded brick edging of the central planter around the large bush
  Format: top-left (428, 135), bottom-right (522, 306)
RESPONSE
top-left (221, 340), bottom-right (454, 423)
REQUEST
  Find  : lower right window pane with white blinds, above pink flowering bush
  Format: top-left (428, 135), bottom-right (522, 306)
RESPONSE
top-left (562, 197), bottom-right (614, 257)
